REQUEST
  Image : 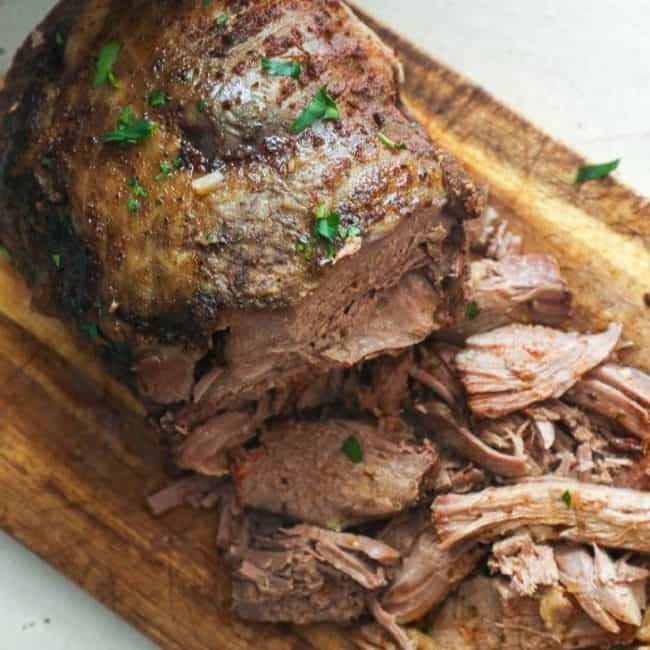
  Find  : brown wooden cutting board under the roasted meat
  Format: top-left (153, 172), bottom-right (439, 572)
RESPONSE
top-left (0, 6), bottom-right (650, 650)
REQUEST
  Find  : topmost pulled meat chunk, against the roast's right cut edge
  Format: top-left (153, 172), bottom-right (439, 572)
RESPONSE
top-left (453, 255), bottom-right (572, 336)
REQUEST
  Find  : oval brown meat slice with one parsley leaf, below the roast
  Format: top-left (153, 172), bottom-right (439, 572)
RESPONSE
top-left (232, 420), bottom-right (437, 529)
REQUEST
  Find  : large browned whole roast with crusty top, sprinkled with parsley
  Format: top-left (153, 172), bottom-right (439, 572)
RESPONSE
top-left (0, 0), bottom-right (485, 450)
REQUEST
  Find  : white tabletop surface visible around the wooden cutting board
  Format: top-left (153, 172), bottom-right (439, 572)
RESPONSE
top-left (0, 0), bottom-right (650, 650)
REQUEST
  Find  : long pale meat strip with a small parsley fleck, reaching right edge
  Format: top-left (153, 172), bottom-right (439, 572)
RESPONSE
top-left (431, 478), bottom-right (650, 553)
